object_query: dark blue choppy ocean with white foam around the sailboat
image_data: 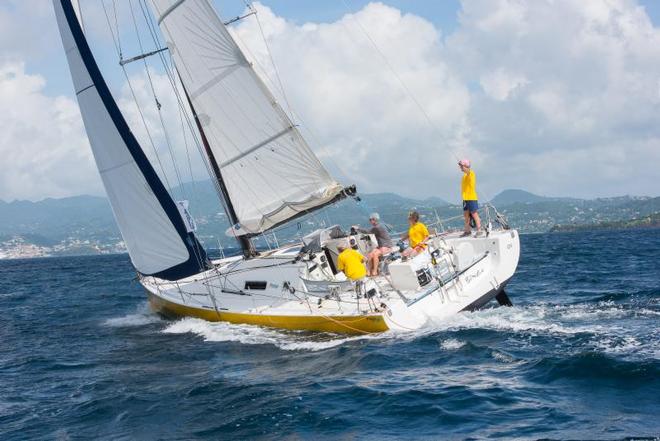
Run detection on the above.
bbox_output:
[0,229,660,440]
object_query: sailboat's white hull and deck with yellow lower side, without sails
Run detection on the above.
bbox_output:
[141,230,520,333]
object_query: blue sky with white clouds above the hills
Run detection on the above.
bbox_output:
[0,0,660,201]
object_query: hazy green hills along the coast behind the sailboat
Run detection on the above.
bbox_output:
[0,180,660,255]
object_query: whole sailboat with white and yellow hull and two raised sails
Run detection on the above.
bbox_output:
[53,0,520,334]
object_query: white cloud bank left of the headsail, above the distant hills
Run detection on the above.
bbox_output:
[0,62,100,200]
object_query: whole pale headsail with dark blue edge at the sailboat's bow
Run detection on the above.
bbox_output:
[53,0,208,280]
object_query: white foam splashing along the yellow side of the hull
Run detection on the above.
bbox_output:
[163,318,382,351]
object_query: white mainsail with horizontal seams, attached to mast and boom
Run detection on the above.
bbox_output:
[152,0,343,235]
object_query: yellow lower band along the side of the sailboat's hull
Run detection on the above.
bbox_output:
[148,293,389,334]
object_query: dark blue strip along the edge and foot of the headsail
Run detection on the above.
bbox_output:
[60,0,211,280]
